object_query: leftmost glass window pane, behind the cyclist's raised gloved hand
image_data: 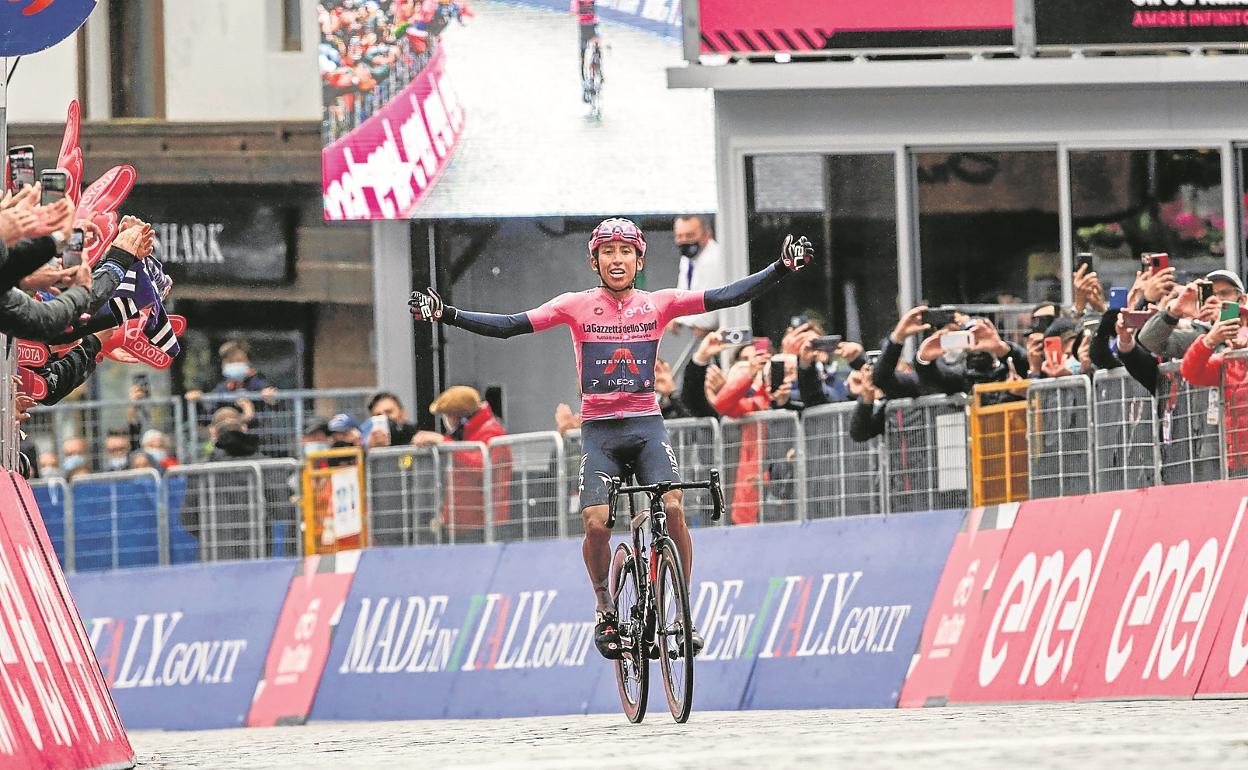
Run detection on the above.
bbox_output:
[745,154,897,348]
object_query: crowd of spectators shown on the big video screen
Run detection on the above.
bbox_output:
[318,0,472,141]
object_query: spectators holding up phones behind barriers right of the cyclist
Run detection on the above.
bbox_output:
[546,255,1248,524]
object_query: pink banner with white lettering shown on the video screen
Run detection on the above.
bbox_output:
[321,49,464,220]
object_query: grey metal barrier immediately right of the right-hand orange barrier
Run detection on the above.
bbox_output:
[1027,374,1096,499]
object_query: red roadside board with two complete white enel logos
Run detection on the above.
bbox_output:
[950,482,1248,703]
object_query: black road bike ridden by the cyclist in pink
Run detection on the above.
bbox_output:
[607,469,724,724]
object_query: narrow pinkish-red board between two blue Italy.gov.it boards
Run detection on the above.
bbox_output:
[247,550,361,728]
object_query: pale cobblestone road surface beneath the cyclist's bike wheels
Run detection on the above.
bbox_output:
[131,701,1248,770]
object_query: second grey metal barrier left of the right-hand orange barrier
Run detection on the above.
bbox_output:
[801,403,887,519]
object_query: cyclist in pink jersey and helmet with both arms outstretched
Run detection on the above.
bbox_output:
[408,218,815,658]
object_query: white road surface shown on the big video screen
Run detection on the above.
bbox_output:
[416,0,715,218]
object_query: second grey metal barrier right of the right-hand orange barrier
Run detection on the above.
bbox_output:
[1092,368,1161,492]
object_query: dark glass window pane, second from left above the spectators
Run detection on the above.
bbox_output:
[914,150,1062,306]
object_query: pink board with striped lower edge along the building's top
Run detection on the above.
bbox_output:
[699,0,1013,54]
